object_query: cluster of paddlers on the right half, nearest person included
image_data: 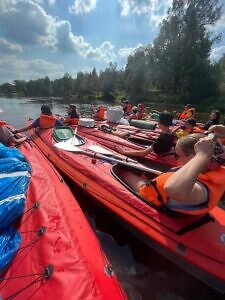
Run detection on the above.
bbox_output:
[89,101,225,214]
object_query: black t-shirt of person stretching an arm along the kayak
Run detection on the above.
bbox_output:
[152,133,173,154]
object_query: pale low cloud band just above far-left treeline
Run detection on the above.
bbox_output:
[0,56,65,83]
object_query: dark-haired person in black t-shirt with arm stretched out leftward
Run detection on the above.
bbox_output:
[117,112,174,157]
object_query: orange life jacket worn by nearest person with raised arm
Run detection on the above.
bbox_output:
[139,166,225,215]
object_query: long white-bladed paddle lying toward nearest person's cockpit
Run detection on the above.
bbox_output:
[54,142,162,175]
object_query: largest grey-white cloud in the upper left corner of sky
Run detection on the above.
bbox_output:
[0,0,115,61]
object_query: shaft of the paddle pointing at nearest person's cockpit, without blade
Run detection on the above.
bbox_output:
[79,149,162,175]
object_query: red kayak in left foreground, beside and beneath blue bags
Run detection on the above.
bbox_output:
[0,142,126,300]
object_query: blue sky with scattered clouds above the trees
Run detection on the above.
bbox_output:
[0,0,225,84]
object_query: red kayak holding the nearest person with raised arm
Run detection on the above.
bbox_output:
[27,127,225,292]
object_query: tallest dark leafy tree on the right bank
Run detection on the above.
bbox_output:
[151,0,222,101]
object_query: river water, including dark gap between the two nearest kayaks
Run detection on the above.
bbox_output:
[0,98,225,300]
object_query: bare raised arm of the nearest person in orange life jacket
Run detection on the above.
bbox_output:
[164,137,213,204]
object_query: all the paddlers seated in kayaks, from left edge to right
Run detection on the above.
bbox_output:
[0,103,225,214]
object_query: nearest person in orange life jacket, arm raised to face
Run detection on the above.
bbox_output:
[123,132,225,215]
